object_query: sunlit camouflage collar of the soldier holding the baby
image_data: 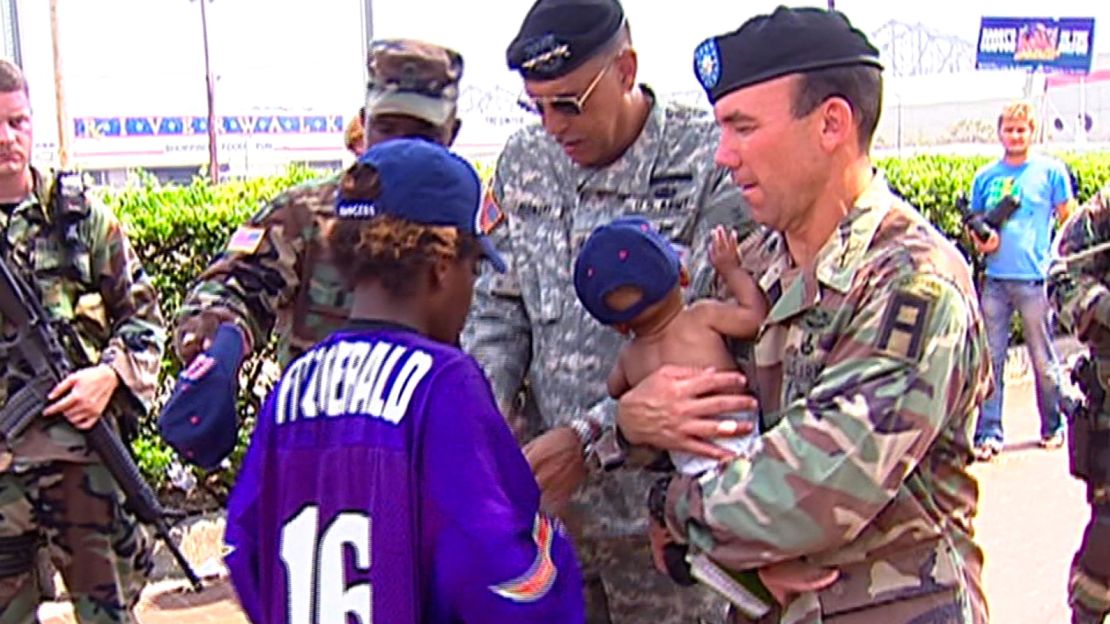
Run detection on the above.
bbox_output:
[815,171,892,293]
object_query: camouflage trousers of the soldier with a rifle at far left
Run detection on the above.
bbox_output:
[0,462,152,624]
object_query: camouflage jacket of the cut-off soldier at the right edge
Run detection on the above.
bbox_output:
[1049,187,1110,429]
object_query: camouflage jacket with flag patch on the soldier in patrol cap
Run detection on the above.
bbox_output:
[174,175,341,366]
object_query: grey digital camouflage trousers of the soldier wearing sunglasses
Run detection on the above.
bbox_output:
[576,535,728,624]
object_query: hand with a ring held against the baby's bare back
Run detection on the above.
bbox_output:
[617,364,757,460]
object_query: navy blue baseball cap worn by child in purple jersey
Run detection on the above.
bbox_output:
[335,139,506,273]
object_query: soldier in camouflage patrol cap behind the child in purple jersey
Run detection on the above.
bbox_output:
[173,40,463,366]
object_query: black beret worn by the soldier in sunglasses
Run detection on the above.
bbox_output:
[505,0,624,80]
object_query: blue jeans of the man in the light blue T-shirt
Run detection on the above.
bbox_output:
[975,278,1063,444]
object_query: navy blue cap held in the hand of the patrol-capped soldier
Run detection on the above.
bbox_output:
[158,323,244,470]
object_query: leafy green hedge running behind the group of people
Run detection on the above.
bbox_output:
[104,153,1110,504]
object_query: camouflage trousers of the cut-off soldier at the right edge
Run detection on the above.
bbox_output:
[1068,506,1110,624]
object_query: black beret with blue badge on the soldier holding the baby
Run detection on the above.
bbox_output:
[694,7,882,103]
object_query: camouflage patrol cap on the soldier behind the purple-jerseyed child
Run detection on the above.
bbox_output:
[366,39,463,125]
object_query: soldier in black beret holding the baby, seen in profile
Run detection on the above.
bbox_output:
[618,7,990,624]
